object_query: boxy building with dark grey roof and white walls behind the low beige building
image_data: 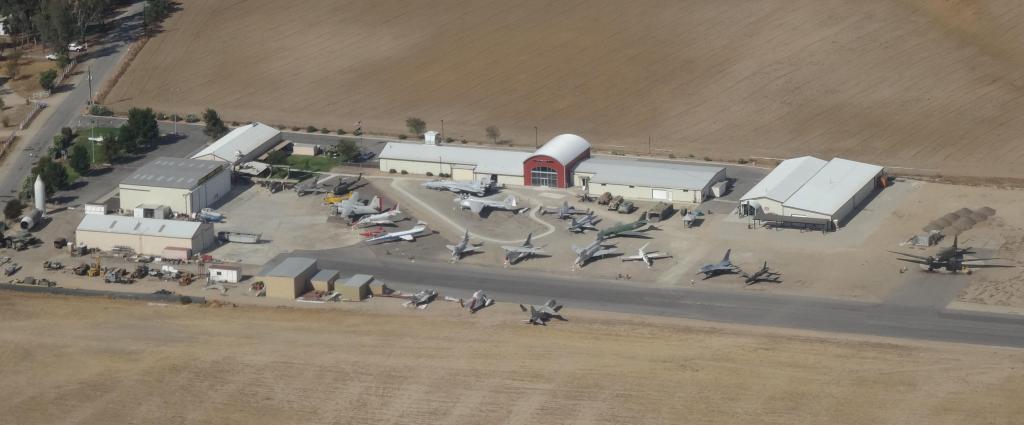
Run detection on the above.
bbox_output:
[118,157,231,214]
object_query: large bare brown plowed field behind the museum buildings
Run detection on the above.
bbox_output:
[105,0,1024,176]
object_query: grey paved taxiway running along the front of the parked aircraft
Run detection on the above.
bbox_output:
[296,248,1024,347]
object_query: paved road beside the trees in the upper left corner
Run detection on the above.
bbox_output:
[0,2,143,201]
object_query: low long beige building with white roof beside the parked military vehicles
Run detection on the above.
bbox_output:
[75,214,216,255]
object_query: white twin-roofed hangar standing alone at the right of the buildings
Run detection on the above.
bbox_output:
[739,157,885,229]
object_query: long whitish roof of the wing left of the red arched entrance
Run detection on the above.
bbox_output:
[378,142,530,176]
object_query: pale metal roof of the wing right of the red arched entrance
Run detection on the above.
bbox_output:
[575,157,725,190]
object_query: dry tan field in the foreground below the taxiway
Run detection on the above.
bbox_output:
[0,292,1024,424]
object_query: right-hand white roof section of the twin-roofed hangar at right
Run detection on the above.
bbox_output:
[782,158,882,215]
